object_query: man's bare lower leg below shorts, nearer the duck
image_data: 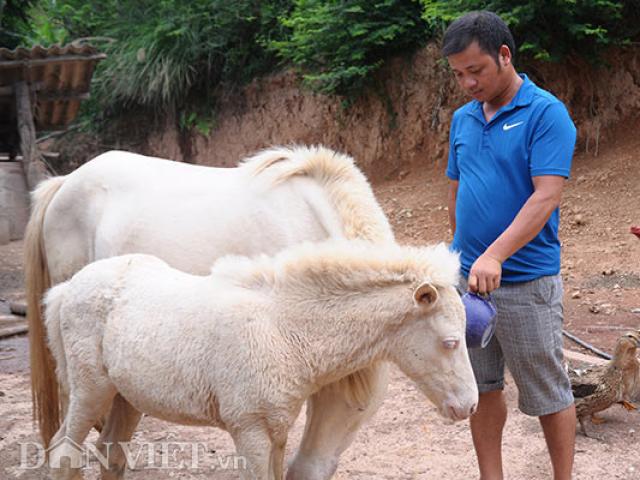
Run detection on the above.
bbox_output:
[540,405,576,480]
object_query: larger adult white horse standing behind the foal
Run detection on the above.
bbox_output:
[25,147,393,480]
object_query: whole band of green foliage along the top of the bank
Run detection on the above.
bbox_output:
[8,0,640,124]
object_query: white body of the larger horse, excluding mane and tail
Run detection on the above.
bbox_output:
[44,151,339,283]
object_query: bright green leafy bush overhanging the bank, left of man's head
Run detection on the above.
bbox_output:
[270,0,427,97]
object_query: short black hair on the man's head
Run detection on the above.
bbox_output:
[442,10,516,63]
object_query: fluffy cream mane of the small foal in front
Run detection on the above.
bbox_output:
[211,239,460,295]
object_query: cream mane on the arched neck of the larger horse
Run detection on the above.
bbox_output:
[241,145,394,243]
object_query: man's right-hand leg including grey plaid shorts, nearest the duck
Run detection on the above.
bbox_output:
[494,275,576,480]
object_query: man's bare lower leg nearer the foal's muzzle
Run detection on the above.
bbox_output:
[470,390,507,480]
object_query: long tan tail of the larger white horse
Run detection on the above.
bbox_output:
[24,177,65,447]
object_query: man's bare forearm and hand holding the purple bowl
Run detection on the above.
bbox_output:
[470,175,565,293]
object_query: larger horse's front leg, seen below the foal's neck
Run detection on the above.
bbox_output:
[287,363,388,480]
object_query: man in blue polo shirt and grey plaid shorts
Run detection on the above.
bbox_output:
[442,12,576,480]
